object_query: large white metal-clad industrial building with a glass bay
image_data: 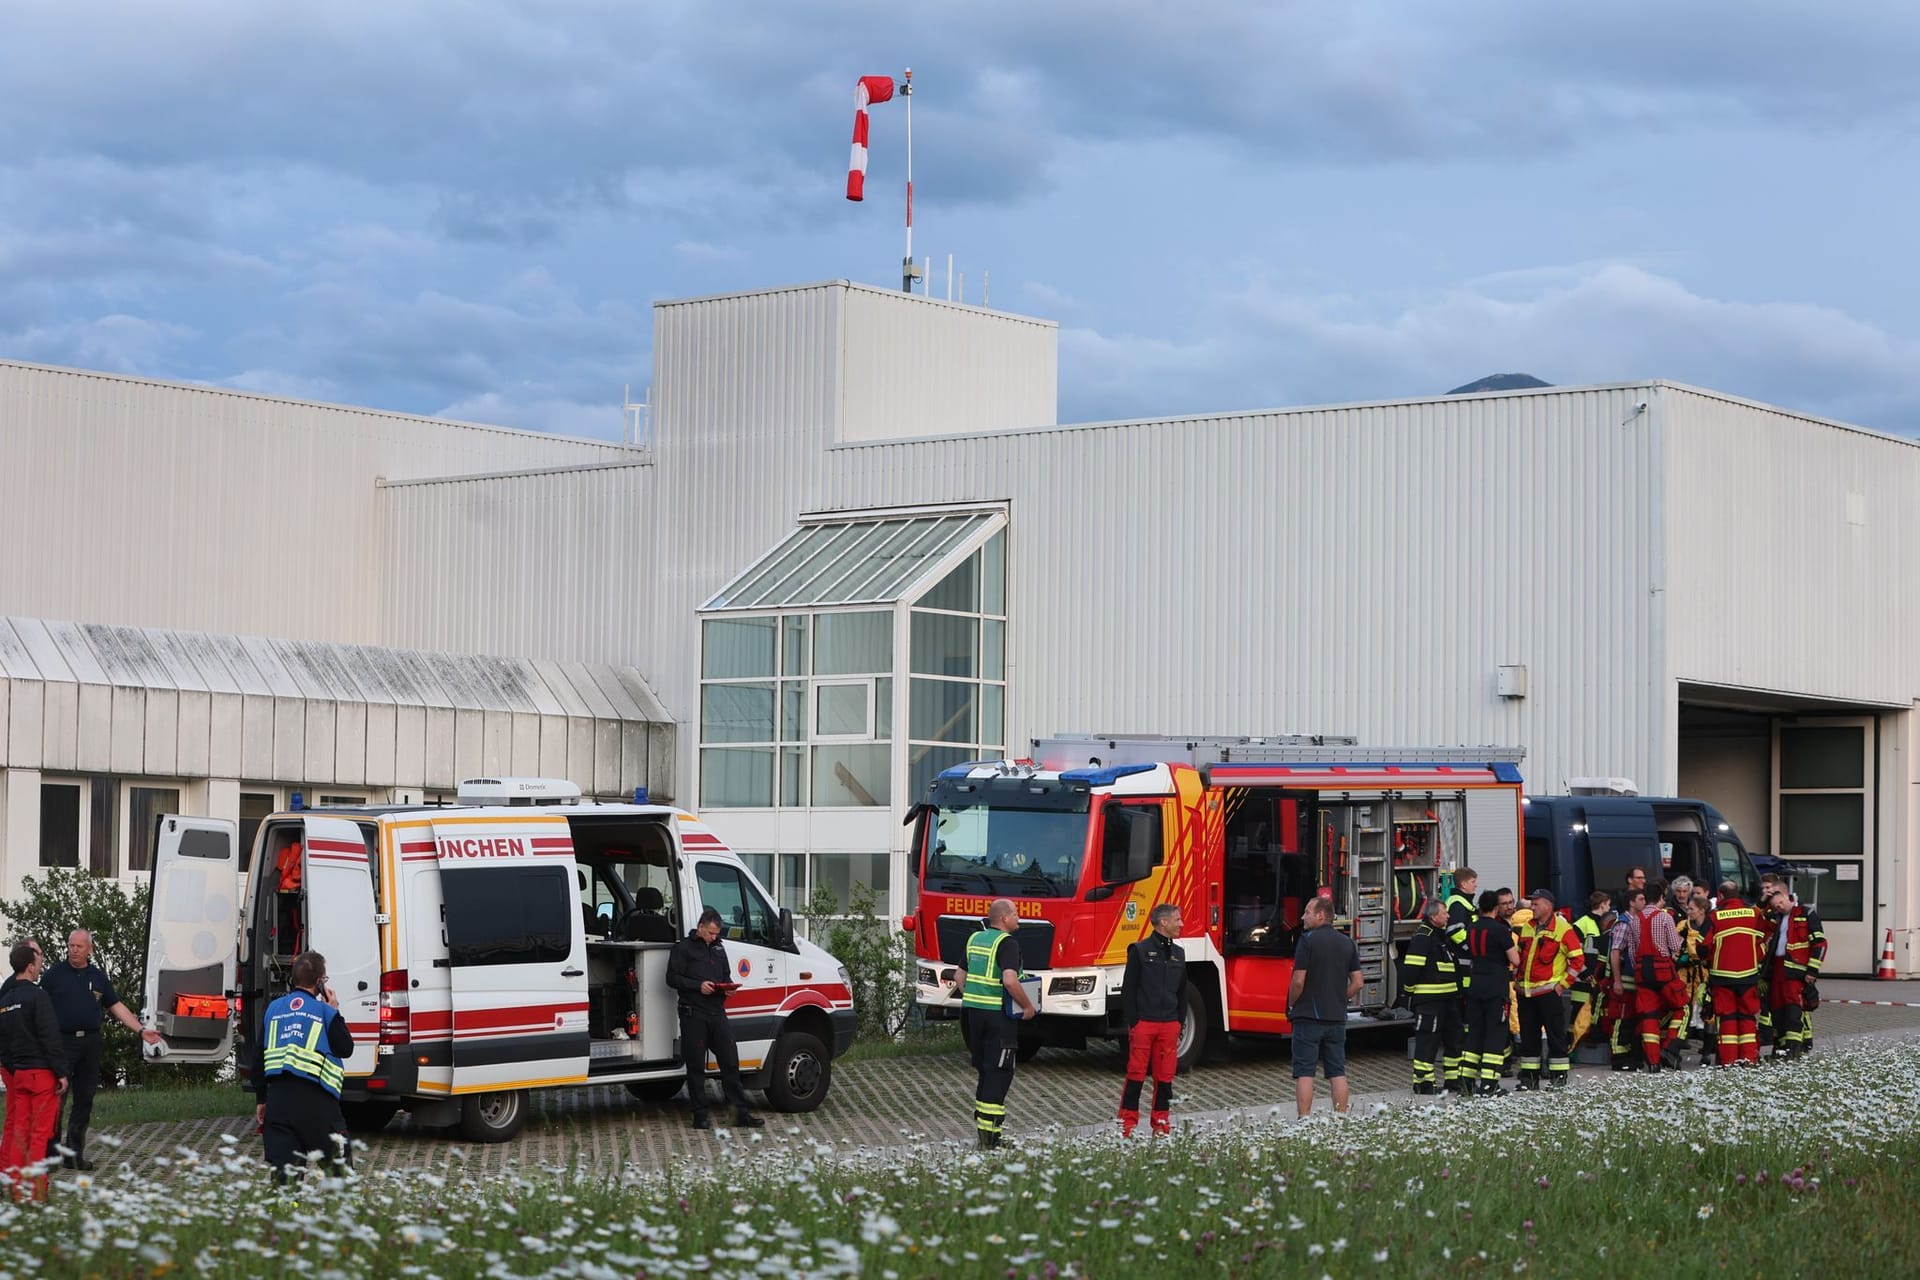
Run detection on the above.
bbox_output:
[0,282,1920,973]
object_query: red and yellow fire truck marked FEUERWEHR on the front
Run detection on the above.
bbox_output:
[904,735,1523,1069]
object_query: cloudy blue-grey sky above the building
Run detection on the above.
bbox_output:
[0,0,1920,436]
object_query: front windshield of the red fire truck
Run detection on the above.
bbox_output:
[924,779,1092,898]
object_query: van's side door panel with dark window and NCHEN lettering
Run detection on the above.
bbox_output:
[434,814,588,1094]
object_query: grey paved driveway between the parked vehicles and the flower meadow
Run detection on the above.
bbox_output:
[90,979,1920,1171]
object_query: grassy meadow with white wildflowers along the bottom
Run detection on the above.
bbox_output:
[0,1042,1920,1280]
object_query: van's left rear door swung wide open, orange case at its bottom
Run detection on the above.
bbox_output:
[142,814,240,1063]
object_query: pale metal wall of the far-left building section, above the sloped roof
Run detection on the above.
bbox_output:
[0,361,632,643]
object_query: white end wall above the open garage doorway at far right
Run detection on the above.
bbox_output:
[1659,386,1920,706]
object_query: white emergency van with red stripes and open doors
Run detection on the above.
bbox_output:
[144,779,854,1142]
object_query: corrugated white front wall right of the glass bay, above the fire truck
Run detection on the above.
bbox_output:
[802,386,1668,802]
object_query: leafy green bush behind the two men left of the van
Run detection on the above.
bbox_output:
[0,867,219,1086]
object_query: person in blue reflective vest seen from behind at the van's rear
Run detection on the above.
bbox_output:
[253,952,353,1182]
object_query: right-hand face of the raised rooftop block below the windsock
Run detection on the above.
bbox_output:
[839,284,1060,441]
